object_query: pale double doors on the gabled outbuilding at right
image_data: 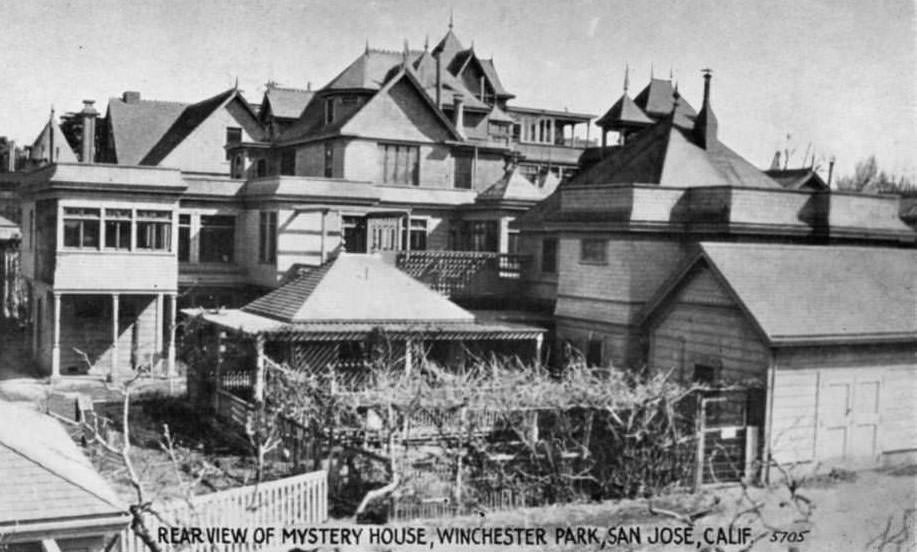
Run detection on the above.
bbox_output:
[818,371,882,468]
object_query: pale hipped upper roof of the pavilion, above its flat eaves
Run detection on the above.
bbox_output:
[242,253,474,323]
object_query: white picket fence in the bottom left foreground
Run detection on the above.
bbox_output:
[120,470,328,552]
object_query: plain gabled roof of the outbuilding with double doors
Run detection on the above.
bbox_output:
[645,242,917,346]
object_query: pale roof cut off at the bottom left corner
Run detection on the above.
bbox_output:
[0,401,127,534]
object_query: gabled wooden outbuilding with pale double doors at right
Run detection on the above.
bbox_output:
[643,242,917,476]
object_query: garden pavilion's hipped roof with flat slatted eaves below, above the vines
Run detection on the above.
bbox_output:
[184,253,546,401]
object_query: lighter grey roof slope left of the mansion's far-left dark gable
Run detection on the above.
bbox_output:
[107,98,188,165]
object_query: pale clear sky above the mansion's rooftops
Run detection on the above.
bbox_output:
[0,0,917,178]
